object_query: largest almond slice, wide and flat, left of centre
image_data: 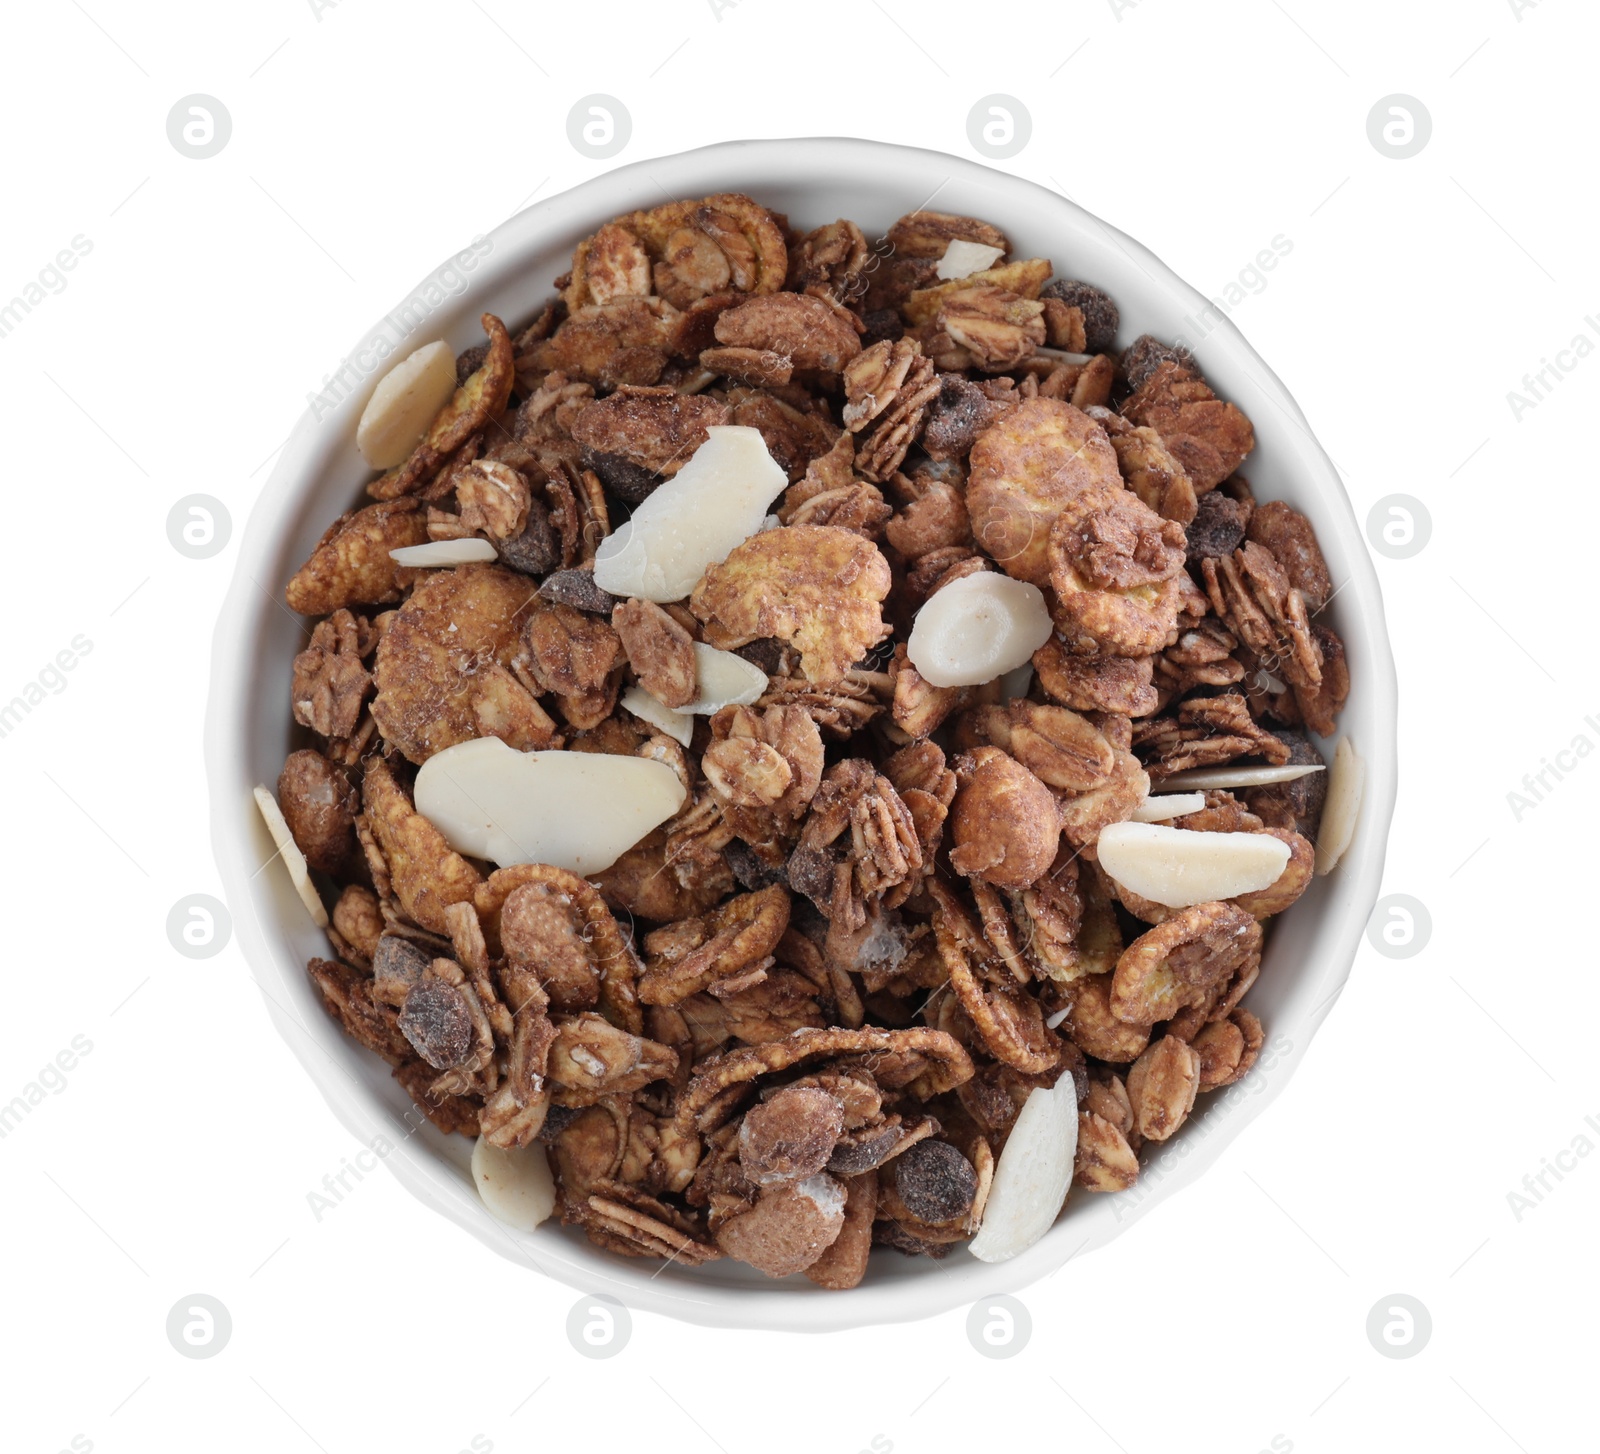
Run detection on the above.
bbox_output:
[416,737,685,873]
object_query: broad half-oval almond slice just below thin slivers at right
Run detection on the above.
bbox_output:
[1096,822,1290,909]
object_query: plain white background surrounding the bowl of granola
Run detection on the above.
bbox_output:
[0,0,1600,1454]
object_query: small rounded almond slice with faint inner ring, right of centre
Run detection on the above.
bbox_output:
[906,571,1053,686]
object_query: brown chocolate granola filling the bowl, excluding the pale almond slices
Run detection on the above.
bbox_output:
[278,194,1349,1289]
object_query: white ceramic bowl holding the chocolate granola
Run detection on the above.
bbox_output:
[206,138,1395,1329]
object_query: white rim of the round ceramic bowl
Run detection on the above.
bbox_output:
[205,136,1398,1331]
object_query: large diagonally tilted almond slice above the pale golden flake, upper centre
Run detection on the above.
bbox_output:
[595,424,789,601]
